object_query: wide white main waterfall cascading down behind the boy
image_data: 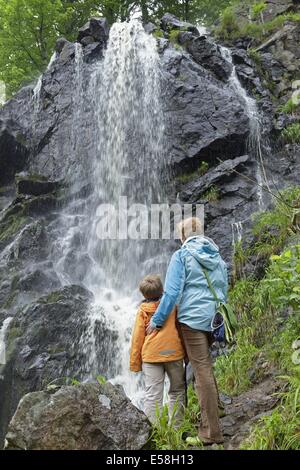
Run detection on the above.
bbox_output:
[53,20,167,403]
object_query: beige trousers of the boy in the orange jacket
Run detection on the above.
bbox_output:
[143,359,185,425]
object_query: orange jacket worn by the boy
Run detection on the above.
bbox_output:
[130,302,184,372]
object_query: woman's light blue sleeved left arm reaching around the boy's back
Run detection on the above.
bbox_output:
[150,250,185,328]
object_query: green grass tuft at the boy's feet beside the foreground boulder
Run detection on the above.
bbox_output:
[150,386,200,450]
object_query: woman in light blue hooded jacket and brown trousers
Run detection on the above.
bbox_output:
[147,217,228,445]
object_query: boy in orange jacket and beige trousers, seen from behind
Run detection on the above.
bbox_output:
[130,275,185,423]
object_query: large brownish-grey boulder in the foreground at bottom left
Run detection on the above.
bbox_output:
[5,383,151,450]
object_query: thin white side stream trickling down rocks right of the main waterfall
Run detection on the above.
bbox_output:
[220,46,268,210]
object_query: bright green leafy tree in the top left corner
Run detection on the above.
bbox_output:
[0,0,63,95]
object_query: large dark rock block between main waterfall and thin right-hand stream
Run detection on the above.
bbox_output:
[162,48,249,169]
